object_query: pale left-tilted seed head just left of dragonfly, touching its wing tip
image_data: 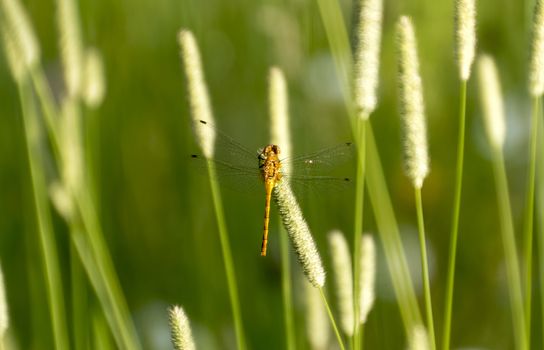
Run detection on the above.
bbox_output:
[178,29,215,158]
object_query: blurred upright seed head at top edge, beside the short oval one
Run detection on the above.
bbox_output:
[57,0,83,97]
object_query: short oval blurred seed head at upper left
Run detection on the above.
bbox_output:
[83,48,106,108]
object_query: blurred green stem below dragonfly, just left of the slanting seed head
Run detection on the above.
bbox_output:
[279,224,296,350]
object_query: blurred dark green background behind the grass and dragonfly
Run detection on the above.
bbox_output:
[0,0,542,349]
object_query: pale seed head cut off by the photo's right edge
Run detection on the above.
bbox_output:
[529,0,544,96]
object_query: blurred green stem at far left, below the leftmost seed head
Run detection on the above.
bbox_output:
[18,81,69,350]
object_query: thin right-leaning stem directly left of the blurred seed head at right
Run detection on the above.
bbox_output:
[442,80,467,350]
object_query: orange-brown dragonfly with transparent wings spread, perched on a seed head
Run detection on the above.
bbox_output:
[191,120,354,256]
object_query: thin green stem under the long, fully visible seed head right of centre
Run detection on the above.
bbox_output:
[415,188,436,350]
